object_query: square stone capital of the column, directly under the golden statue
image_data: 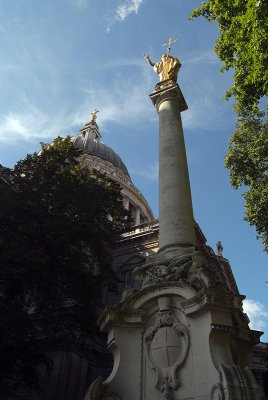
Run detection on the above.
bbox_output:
[150,80,188,112]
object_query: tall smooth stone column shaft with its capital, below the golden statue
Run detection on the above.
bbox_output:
[150,83,195,253]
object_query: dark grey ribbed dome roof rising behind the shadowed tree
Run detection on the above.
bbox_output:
[73,135,130,179]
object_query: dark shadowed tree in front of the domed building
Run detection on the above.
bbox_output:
[0,137,128,399]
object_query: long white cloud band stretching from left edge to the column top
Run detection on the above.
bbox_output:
[0,74,157,143]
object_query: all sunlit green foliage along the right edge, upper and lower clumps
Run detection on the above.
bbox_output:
[190,0,268,251]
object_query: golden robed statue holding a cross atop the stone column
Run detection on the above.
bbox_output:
[144,38,181,82]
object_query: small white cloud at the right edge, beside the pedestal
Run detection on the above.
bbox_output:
[243,299,268,331]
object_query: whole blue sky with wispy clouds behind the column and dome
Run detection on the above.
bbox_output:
[0,0,268,341]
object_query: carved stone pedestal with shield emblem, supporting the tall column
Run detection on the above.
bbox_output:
[86,253,259,400]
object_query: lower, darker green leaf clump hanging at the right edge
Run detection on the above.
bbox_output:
[226,119,268,251]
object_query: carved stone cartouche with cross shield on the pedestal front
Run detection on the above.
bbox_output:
[145,297,190,399]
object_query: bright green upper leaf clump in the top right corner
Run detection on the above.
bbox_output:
[191,0,268,115]
